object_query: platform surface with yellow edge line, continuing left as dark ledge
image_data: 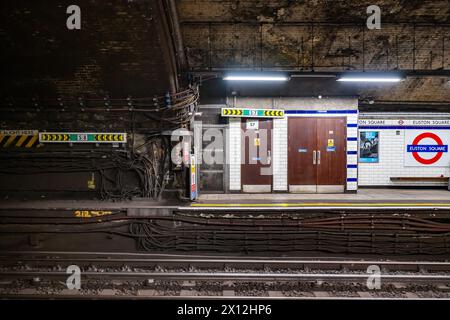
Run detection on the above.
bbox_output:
[0,188,450,212]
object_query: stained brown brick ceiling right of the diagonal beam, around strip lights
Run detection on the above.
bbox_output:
[177,0,450,105]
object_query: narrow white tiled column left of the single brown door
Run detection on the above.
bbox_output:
[227,118,241,191]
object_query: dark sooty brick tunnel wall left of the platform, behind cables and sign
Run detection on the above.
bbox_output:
[0,0,186,199]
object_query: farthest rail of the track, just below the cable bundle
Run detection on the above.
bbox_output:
[0,251,450,272]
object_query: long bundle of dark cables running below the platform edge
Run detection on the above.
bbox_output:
[129,215,450,254]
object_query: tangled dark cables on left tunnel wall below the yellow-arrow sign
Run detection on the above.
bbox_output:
[0,137,170,199]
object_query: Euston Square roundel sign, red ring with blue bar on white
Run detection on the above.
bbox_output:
[404,130,450,167]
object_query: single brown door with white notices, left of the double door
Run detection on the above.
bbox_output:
[241,119,272,192]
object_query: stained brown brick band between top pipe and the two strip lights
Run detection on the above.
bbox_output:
[182,21,450,72]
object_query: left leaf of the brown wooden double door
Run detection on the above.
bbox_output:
[288,118,317,192]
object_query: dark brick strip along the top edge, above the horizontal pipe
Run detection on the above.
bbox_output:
[177,0,450,23]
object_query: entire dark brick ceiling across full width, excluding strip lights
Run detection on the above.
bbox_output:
[0,0,450,105]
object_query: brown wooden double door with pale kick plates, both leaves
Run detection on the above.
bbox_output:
[288,117,347,193]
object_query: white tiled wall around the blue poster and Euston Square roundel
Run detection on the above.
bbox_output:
[358,129,450,186]
